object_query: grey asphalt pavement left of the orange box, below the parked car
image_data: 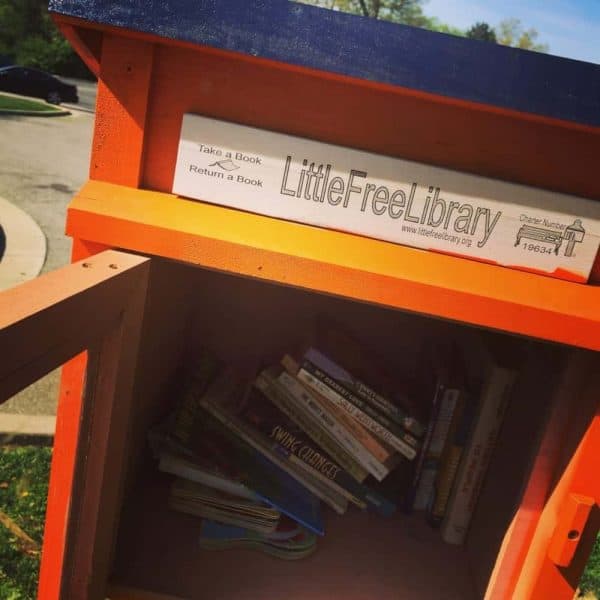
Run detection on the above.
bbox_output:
[0,81,95,415]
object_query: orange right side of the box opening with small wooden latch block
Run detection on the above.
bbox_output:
[486,351,600,600]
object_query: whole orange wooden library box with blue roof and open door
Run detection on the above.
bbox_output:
[0,0,600,600]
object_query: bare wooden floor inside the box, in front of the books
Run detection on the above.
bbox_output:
[112,474,475,600]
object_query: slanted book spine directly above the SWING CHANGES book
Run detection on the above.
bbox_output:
[256,373,367,482]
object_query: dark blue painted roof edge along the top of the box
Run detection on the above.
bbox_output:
[50,0,600,127]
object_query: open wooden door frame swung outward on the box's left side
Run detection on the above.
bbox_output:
[0,251,150,600]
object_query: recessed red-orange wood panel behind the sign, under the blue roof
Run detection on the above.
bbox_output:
[142,45,600,204]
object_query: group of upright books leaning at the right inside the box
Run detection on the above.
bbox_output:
[407,335,518,544]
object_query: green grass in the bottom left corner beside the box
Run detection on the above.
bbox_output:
[0,446,52,600]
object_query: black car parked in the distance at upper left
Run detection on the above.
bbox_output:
[0,66,79,104]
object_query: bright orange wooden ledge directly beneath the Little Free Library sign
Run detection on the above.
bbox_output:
[67,181,600,349]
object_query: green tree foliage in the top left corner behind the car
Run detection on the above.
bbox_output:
[0,0,91,78]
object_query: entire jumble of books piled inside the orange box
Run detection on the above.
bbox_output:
[150,328,516,559]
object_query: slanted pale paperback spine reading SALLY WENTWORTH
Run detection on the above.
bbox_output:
[298,361,417,460]
